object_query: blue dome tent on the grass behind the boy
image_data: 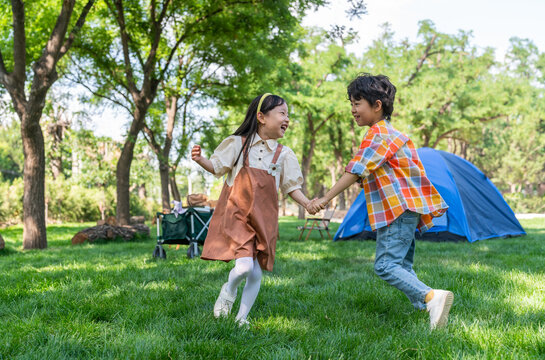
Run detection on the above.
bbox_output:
[334,148,526,242]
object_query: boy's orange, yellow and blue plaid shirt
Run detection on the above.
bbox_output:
[345,120,448,233]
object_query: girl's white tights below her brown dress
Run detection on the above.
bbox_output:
[223,257,262,320]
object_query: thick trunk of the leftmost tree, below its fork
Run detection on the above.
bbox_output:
[21,112,47,250]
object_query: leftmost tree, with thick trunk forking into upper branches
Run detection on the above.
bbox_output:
[0,0,94,249]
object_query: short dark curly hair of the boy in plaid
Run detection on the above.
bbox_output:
[346,73,397,120]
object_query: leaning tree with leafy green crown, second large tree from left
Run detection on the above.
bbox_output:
[73,0,323,224]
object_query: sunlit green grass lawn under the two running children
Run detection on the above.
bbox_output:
[0,218,545,359]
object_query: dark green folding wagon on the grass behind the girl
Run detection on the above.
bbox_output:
[153,207,214,259]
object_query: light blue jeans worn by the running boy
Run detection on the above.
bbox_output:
[375,211,431,310]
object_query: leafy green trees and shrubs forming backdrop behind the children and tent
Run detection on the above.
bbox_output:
[0,0,545,248]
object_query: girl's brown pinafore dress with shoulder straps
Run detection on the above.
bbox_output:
[201,144,282,271]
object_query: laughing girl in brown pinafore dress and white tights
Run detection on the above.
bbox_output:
[191,94,309,325]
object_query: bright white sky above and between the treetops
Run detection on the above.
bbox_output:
[93,0,545,140]
